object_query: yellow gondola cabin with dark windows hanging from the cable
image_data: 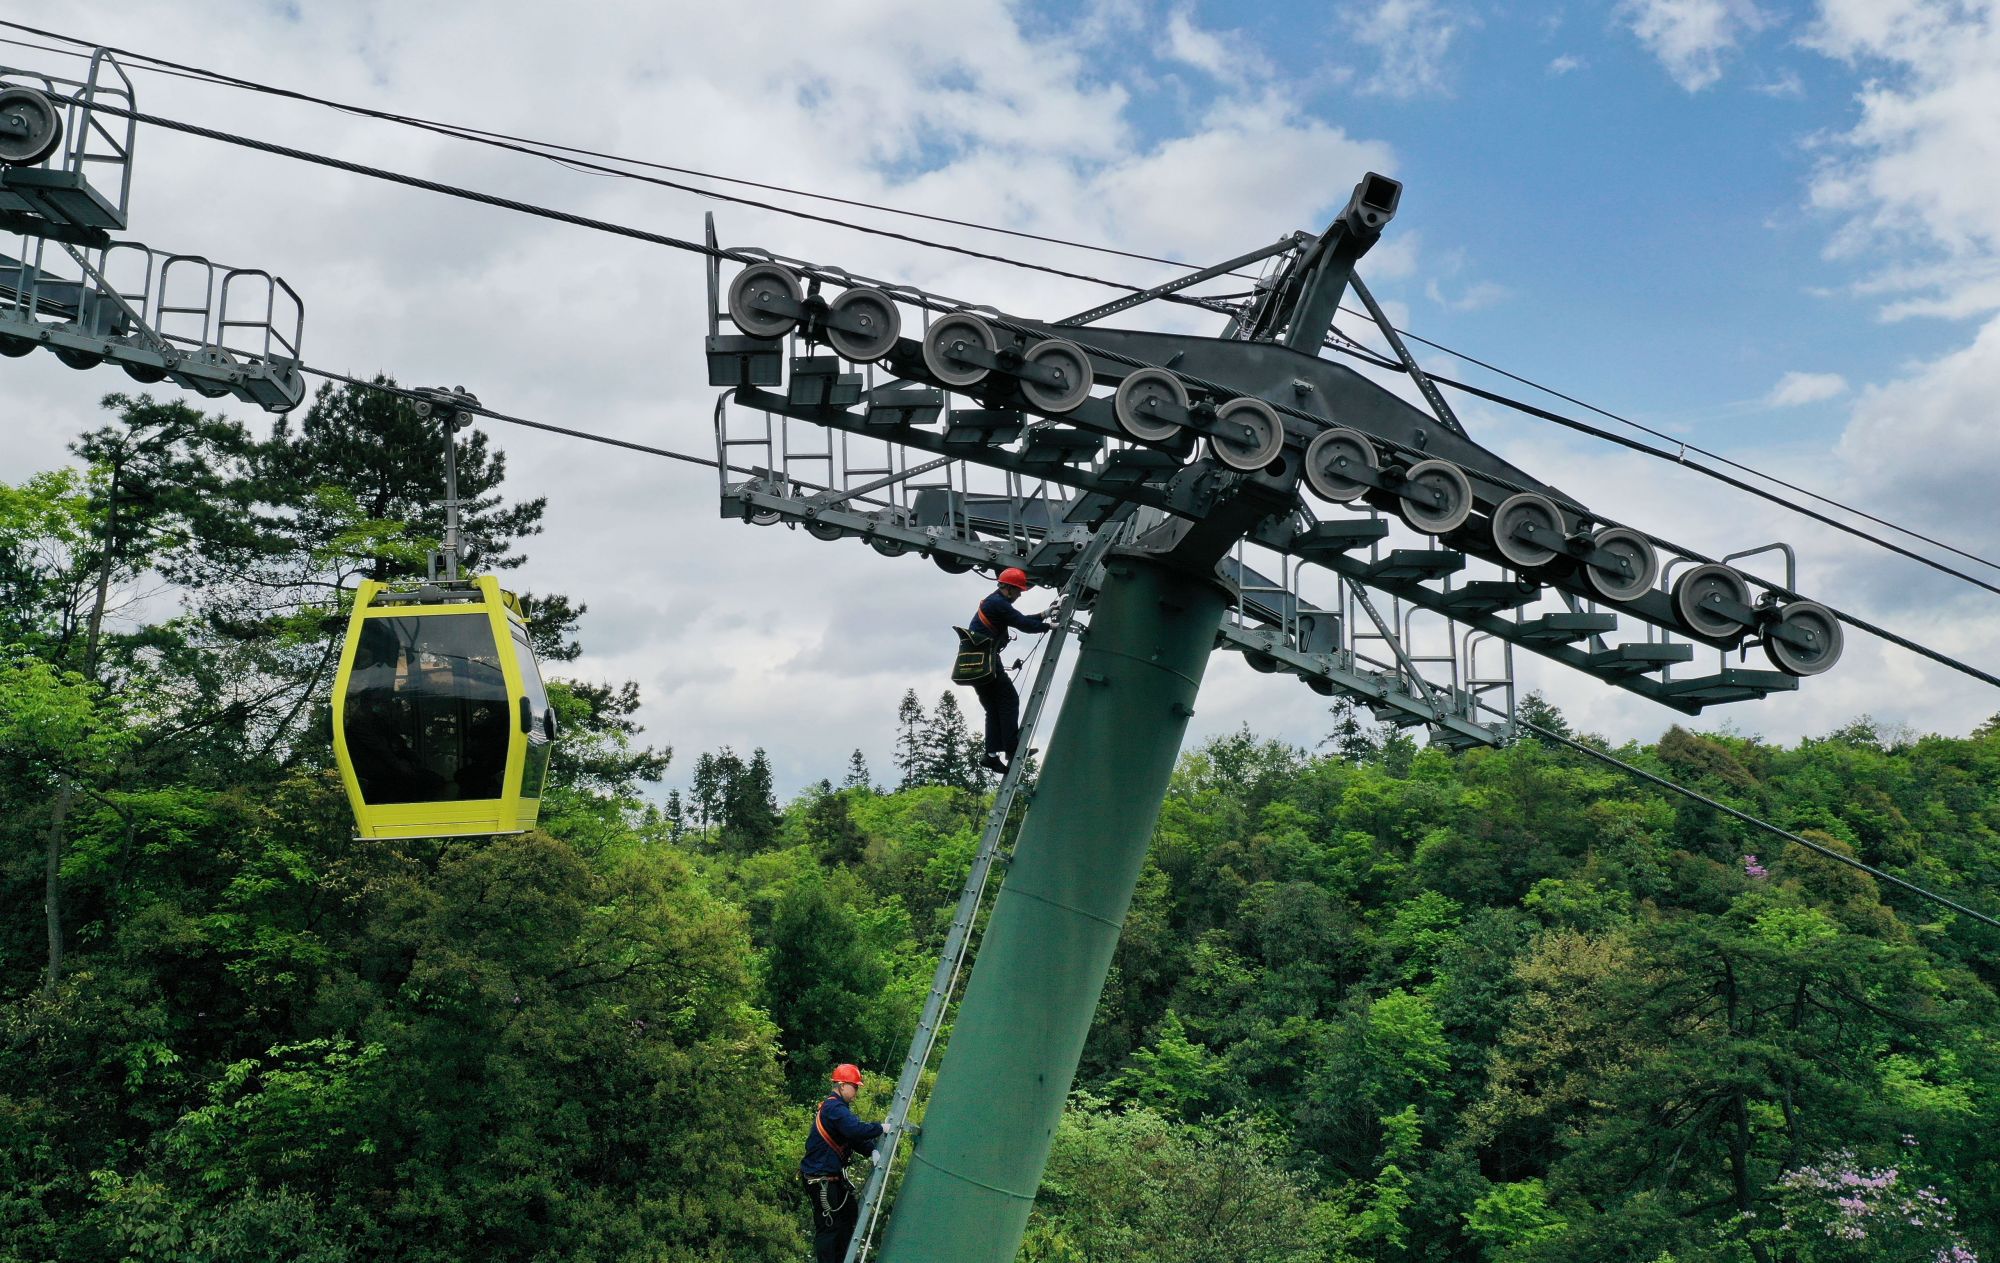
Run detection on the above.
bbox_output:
[334,576,556,837]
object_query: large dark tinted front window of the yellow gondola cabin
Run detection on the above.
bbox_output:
[342,614,514,803]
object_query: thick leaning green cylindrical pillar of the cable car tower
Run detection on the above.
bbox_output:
[880,554,1228,1263]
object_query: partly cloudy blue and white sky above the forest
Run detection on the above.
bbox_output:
[0,0,2000,793]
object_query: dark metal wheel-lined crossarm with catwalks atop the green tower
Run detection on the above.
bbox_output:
[706,190,1838,743]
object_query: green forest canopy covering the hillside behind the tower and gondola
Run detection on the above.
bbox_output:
[0,390,2000,1263]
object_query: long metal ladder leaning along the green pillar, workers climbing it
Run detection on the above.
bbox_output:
[846,518,1126,1263]
